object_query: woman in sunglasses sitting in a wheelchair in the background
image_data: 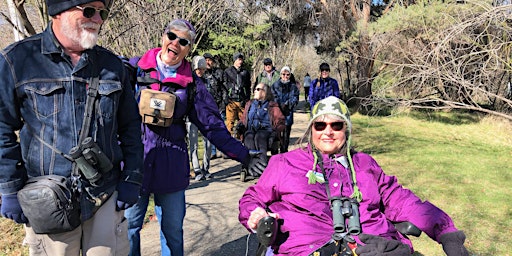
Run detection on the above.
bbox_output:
[236,83,286,177]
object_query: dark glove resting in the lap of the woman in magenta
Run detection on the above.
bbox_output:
[356,234,411,256]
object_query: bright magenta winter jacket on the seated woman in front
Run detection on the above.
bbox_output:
[239,149,457,255]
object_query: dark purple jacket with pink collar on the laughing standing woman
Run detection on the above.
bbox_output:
[138,48,248,193]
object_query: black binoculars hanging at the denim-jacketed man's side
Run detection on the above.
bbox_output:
[69,137,114,186]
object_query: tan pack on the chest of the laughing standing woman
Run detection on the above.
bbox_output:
[139,89,176,127]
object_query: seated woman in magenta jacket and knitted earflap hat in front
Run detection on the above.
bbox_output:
[239,96,468,256]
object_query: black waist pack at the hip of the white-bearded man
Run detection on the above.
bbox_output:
[18,175,81,234]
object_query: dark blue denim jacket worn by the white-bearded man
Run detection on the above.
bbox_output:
[0,23,143,219]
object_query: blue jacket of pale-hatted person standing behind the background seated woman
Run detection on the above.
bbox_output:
[272,79,300,126]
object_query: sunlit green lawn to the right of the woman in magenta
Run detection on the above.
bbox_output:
[0,109,512,256]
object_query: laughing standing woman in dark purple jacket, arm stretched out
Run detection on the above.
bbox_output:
[125,20,249,256]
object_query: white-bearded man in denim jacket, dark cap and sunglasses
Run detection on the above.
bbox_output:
[0,0,143,256]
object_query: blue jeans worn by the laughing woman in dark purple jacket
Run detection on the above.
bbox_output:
[125,190,185,256]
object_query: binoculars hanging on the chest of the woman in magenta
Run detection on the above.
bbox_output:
[331,197,361,239]
